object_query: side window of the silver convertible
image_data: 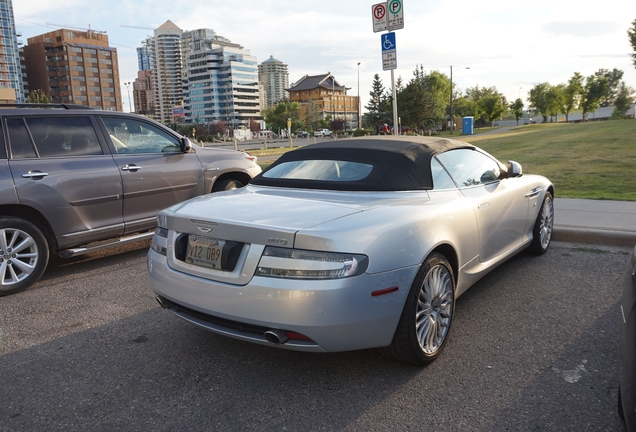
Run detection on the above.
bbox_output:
[437,149,500,187]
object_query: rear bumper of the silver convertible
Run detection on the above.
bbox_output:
[148,250,418,352]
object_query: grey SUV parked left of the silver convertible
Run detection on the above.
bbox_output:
[0,105,261,295]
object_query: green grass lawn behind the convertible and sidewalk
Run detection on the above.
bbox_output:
[250,120,636,201]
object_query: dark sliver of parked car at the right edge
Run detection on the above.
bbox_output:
[618,246,636,431]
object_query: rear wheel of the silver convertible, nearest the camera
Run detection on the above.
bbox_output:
[382,252,455,366]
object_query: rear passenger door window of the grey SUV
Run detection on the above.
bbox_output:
[25,117,103,158]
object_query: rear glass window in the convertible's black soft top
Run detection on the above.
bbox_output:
[263,160,373,182]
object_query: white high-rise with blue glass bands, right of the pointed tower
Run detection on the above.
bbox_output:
[183,32,262,129]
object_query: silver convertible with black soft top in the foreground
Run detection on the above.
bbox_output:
[148,137,554,365]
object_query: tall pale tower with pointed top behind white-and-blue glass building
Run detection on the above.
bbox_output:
[144,20,183,124]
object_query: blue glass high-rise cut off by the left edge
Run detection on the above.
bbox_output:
[0,0,24,103]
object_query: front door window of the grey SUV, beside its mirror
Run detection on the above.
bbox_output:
[102,116,181,154]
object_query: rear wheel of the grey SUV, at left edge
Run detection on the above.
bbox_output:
[0,217,49,297]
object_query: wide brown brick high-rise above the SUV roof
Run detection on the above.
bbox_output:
[23,29,122,111]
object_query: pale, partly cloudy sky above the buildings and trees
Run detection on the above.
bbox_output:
[13,0,636,113]
